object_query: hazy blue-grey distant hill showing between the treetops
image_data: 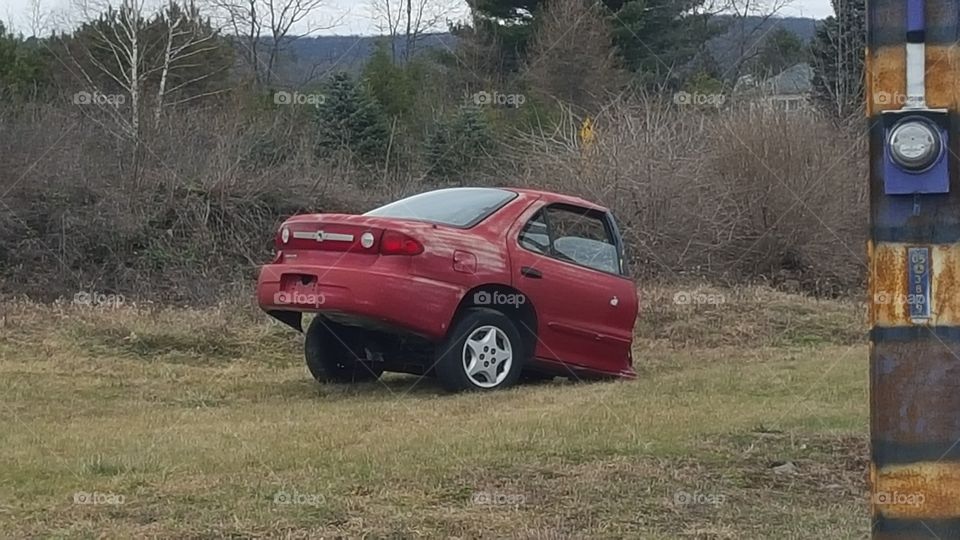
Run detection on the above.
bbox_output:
[276,16,819,84]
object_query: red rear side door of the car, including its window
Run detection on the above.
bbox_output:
[508,203,637,373]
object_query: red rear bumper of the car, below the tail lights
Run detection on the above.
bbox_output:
[257,264,466,340]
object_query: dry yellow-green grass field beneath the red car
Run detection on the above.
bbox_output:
[0,290,869,539]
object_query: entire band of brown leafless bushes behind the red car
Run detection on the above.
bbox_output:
[0,87,867,302]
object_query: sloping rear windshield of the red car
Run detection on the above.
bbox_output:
[364,188,517,228]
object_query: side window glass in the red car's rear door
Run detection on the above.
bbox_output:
[518,206,622,275]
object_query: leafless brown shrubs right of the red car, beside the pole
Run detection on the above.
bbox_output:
[502,96,867,294]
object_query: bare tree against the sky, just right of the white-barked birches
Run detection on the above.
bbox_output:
[211,0,342,85]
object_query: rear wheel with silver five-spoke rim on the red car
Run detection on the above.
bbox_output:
[436,308,527,392]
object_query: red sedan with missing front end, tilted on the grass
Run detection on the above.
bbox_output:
[257,188,638,391]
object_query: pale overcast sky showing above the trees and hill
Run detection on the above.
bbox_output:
[0,0,833,35]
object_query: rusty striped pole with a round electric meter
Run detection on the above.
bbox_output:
[866,0,960,539]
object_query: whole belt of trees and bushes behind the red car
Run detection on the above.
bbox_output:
[0,0,864,299]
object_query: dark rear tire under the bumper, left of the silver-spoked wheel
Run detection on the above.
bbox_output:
[304,315,383,383]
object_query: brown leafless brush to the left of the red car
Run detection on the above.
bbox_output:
[0,100,379,302]
